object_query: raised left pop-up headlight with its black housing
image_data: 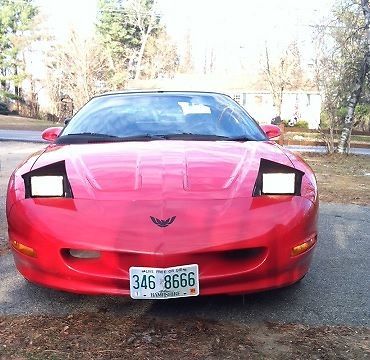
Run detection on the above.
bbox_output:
[23,161,73,198]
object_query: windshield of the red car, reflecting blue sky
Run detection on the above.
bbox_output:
[57,93,266,143]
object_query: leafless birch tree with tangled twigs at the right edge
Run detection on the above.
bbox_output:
[315,0,369,153]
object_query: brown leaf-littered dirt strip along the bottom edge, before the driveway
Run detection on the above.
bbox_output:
[0,311,370,360]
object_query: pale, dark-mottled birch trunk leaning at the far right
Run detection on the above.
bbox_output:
[338,0,370,154]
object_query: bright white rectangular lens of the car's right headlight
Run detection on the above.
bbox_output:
[262,173,295,194]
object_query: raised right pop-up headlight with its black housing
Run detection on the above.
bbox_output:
[253,159,304,196]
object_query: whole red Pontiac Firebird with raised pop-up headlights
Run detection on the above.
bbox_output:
[6,91,318,299]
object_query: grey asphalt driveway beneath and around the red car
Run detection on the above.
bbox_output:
[0,143,370,326]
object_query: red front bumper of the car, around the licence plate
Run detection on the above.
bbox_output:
[8,196,317,296]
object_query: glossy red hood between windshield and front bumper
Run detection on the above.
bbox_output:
[32,140,292,200]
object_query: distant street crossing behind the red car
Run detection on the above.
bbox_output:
[0,130,370,155]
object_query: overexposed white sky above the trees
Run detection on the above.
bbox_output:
[36,0,334,72]
